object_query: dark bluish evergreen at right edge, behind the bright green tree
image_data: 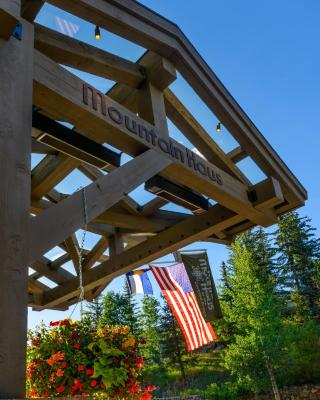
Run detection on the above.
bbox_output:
[275,212,320,316]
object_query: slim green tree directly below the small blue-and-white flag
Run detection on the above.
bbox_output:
[139,296,161,365]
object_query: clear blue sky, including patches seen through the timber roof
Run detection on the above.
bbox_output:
[29,0,320,327]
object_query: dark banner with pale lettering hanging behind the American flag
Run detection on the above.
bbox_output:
[180,252,222,321]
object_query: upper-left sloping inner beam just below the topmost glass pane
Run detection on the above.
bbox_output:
[35,24,146,87]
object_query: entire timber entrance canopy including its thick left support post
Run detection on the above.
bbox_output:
[0,0,307,398]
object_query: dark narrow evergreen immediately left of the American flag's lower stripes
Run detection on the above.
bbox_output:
[160,301,186,381]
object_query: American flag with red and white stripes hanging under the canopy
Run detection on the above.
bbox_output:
[150,263,216,351]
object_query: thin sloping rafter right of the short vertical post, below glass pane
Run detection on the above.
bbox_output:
[164,89,250,185]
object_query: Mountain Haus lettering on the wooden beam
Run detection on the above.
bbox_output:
[83,83,223,186]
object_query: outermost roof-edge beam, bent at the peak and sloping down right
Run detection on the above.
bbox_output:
[44,0,307,203]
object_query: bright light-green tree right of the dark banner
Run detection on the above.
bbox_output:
[224,230,282,399]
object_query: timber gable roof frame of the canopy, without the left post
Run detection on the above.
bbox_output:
[5,0,307,310]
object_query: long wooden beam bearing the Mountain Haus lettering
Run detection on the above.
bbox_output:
[34,51,275,225]
